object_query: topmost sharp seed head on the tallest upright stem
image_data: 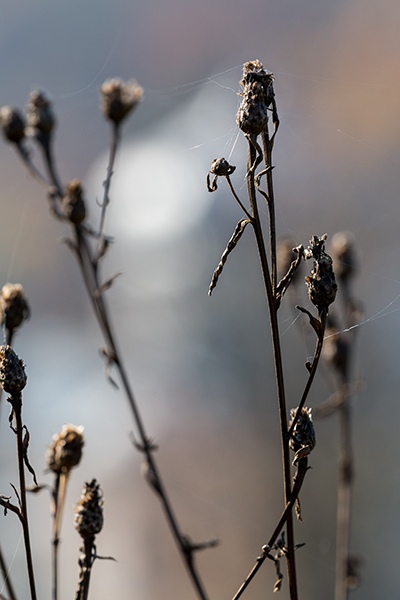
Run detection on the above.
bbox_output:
[236,60,275,135]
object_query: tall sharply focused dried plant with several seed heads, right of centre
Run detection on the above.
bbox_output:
[207,60,337,600]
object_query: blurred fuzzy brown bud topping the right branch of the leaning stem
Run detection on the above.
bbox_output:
[100,79,143,125]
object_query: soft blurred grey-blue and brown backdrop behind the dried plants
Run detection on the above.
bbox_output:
[0,0,400,600]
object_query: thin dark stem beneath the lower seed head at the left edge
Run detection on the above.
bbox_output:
[11,395,36,600]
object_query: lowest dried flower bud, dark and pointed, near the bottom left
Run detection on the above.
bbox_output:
[74,479,104,538]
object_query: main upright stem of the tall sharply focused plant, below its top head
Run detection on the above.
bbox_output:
[247,139,298,600]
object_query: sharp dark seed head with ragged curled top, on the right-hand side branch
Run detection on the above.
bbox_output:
[304,235,338,312]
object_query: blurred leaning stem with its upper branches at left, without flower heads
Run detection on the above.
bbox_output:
[25,130,211,600]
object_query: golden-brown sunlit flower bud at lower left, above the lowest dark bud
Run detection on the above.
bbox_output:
[46,425,85,473]
